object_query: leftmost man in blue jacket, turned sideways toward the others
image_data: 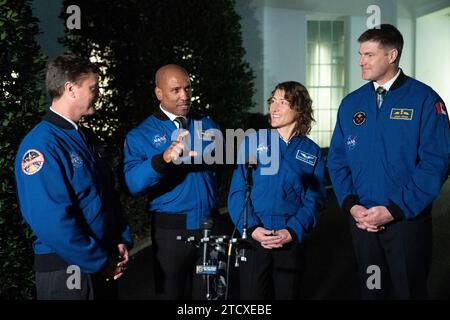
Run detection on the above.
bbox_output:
[15,55,131,300]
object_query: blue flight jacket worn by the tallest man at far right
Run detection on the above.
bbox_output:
[328,72,450,220]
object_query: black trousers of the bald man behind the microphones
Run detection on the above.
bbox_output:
[152,214,206,300]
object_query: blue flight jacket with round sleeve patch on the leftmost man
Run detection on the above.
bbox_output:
[14,111,132,273]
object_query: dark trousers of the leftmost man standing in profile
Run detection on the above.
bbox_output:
[36,269,118,300]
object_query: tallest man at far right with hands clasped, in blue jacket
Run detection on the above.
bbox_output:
[328,24,450,299]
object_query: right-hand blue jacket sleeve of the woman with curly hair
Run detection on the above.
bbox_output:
[287,150,326,242]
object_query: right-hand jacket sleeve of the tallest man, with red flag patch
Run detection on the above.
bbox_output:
[388,94,450,219]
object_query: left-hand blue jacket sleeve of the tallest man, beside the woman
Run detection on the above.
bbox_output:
[327,104,359,212]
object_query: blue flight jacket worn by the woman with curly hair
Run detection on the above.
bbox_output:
[228,129,325,242]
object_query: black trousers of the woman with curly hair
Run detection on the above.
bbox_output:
[239,239,305,300]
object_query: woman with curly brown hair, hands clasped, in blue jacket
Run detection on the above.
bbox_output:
[228,81,325,299]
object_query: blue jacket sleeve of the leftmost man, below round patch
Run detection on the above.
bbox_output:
[15,147,108,273]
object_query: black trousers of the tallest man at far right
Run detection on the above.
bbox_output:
[349,213,432,300]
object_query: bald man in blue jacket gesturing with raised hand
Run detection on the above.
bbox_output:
[124,64,221,299]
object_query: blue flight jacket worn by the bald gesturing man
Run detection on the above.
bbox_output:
[124,108,223,230]
